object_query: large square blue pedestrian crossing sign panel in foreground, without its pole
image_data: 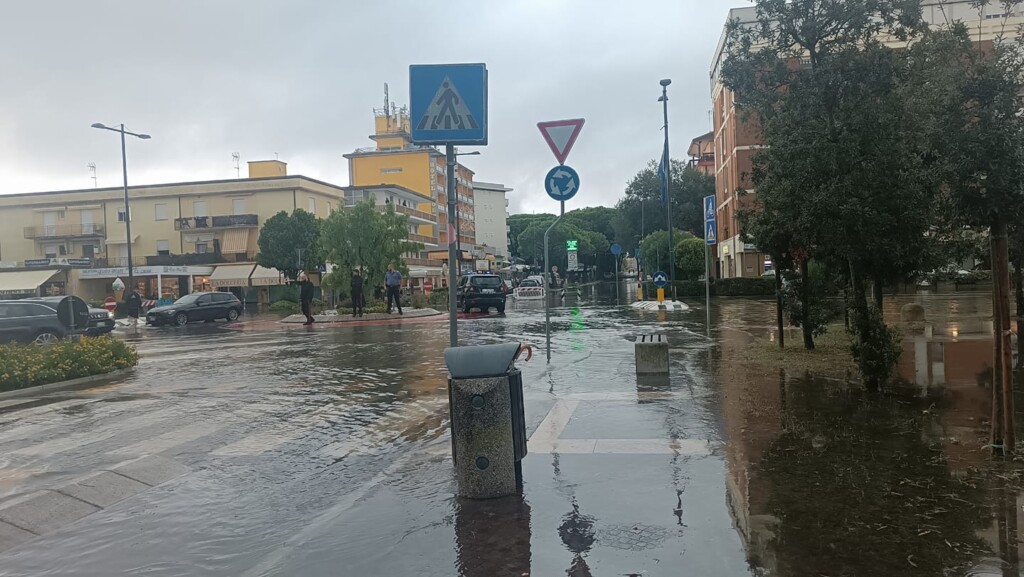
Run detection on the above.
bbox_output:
[409,64,487,145]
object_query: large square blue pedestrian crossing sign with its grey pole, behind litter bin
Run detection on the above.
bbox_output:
[409,64,487,346]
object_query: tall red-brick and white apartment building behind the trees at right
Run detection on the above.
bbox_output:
[708,0,1024,278]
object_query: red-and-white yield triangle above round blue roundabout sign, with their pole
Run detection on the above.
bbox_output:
[537,118,585,363]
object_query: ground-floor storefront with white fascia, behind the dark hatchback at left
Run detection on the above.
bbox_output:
[75,266,214,300]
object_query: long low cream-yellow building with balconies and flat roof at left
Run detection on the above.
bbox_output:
[0,161,345,301]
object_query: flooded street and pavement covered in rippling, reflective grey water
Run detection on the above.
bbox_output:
[0,292,1024,577]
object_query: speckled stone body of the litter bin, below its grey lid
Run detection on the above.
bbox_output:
[450,376,517,499]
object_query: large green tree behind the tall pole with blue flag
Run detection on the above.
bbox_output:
[614,160,715,252]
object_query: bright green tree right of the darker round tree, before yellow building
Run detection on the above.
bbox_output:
[322,199,423,287]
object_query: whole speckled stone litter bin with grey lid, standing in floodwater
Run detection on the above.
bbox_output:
[444,343,526,499]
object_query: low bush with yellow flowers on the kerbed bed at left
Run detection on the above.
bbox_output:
[0,336,138,390]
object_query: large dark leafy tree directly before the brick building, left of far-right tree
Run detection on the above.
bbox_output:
[723,0,937,379]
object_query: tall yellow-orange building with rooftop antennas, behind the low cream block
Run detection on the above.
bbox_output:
[345,108,476,278]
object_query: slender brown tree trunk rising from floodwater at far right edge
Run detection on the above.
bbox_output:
[991,216,1017,455]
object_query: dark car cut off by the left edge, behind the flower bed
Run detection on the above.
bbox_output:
[0,296,89,344]
